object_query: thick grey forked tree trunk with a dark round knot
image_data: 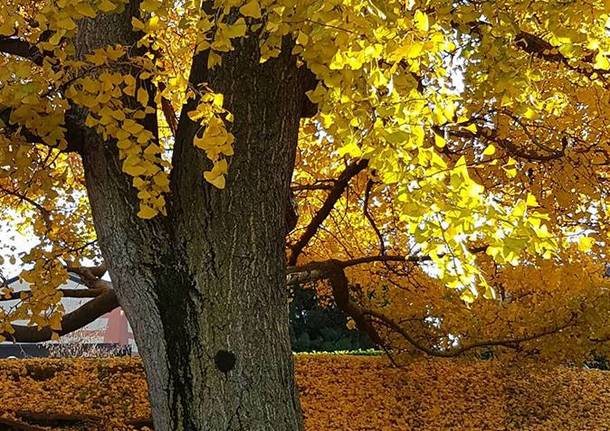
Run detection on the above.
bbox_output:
[74,2,306,431]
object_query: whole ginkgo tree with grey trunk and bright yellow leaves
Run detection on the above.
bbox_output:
[0,0,610,430]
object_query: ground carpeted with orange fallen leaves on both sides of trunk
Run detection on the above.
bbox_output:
[0,355,610,431]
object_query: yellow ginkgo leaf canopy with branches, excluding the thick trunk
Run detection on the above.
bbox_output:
[0,0,610,360]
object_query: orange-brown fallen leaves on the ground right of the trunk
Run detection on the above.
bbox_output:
[296,355,610,431]
